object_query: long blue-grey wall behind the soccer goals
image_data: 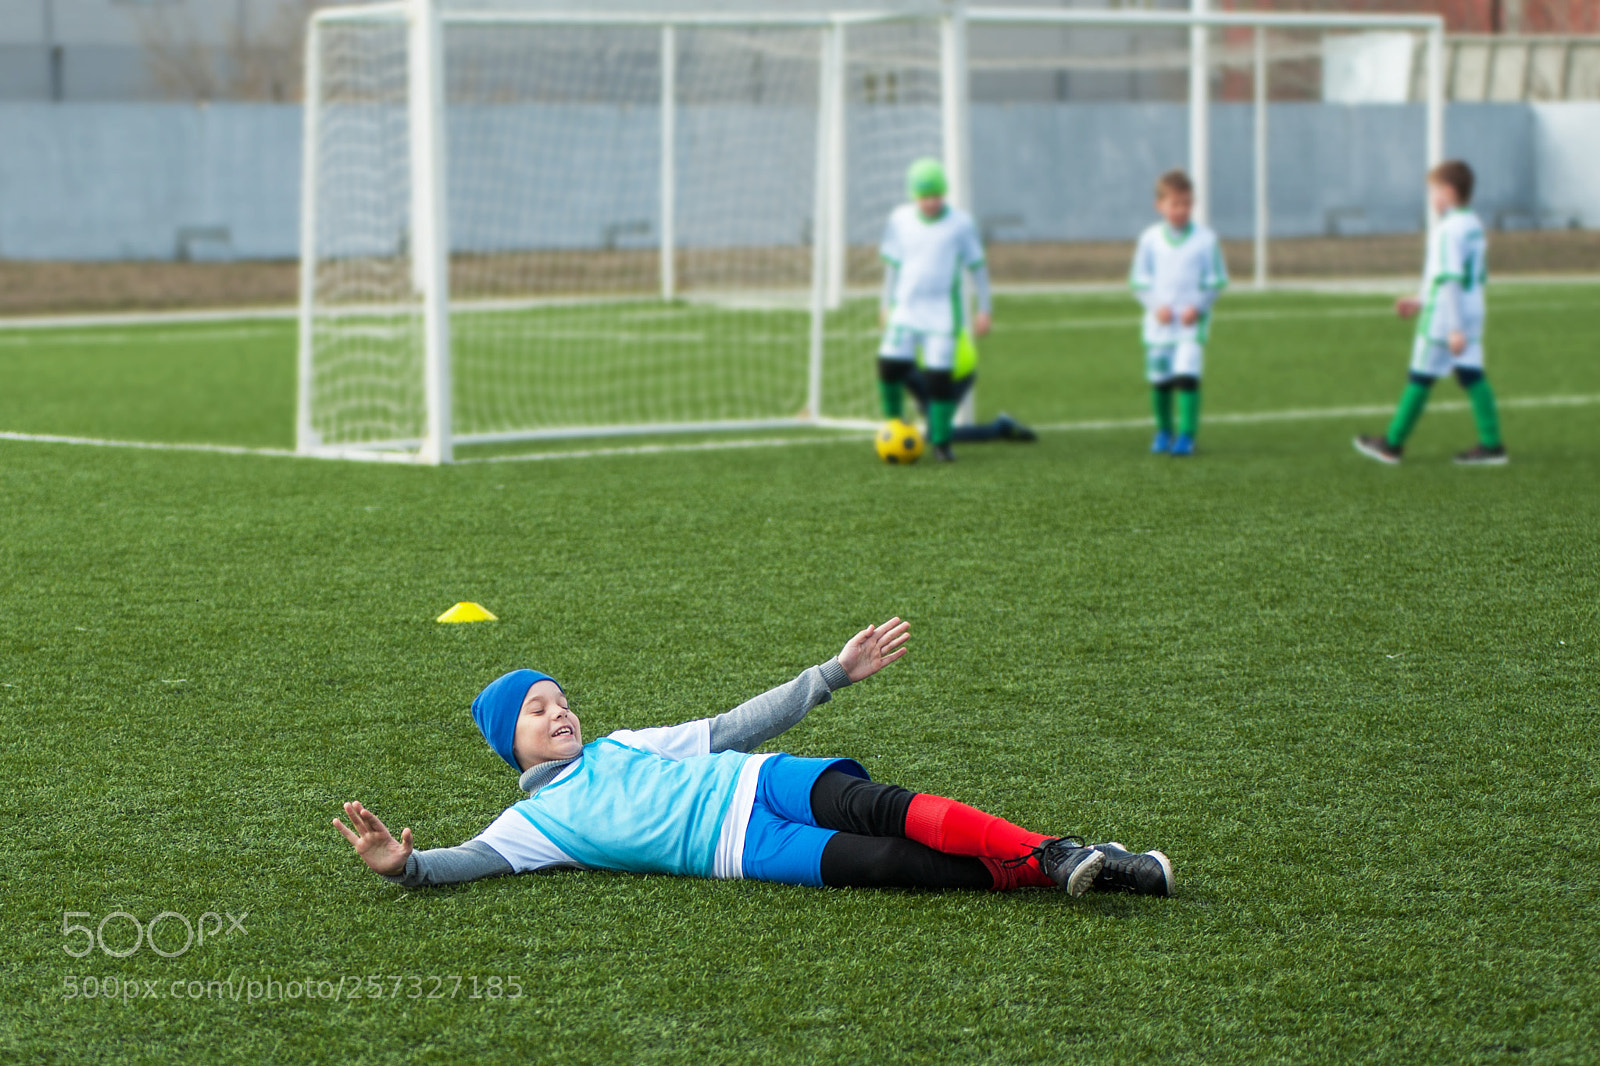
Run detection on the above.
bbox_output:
[0,104,1600,259]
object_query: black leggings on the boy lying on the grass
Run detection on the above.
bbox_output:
[811,770,994,888]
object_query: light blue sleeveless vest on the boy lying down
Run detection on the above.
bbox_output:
[514,738,750,877]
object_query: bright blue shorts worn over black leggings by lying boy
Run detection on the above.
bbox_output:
[744,755,867,888]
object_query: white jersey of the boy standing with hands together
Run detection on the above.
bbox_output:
[1128,222,1227,346]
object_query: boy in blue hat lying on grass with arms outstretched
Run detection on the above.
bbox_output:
[333,618,1173,896]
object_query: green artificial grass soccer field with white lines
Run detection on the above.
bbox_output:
[0,285,1600,1064]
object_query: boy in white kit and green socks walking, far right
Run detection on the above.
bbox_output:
[1355,160,1506,466]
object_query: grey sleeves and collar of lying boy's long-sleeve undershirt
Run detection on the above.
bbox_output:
[384,658,850,888]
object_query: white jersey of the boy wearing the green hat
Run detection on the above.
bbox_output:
[878,203,984,333]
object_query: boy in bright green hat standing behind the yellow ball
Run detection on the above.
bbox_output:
[878,158,990,463]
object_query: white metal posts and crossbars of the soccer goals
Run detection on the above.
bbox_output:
[296,0,1445,464]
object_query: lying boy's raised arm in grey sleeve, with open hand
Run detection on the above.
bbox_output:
[710,618,910,751]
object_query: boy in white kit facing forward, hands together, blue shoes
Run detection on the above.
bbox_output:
[1128,170,1227,456]
